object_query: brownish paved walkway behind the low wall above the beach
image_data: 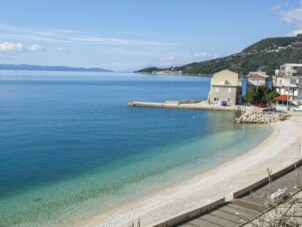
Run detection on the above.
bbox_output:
[178,166,302,227]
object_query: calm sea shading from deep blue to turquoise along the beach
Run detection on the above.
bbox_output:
[0,72,271,226]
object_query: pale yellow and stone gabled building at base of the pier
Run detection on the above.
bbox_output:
[208,70,240,105]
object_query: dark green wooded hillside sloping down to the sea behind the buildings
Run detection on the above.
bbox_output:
[136,35,302,75]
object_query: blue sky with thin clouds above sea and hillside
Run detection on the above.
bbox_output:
[0,0,302,71]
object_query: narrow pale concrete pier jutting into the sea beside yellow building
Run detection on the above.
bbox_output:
[128,100,245,111]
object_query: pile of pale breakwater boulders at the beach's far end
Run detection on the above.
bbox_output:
[234,108,287,124]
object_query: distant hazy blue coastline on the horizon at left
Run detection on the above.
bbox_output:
[0,64,113,72]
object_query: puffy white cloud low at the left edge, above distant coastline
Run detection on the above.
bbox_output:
[0,42,44,54]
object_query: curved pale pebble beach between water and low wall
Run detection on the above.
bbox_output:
[78,117,302,226]
